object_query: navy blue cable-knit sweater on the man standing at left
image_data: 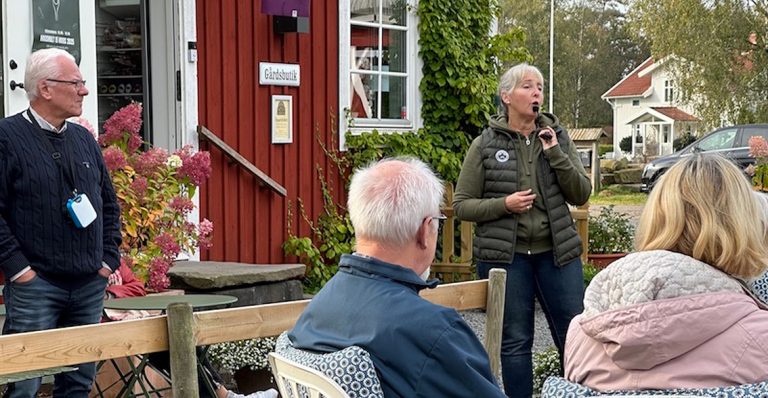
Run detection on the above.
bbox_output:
[0,113,121,287]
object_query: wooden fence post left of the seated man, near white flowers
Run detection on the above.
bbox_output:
[168,303,200,398]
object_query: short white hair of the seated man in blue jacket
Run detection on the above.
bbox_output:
[347,157,444,246]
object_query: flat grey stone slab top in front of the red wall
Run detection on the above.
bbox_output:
[168,261,306,290]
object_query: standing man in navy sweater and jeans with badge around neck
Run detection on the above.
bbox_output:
[0,49,120,397]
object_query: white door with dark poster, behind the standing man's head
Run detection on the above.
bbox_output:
[0,0,96,124]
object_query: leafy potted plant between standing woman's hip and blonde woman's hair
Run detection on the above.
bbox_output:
[587,205,635,268]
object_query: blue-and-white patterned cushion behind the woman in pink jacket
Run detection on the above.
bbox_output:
[541,376,768,398]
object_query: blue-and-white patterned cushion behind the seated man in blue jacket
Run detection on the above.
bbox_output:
[275,333,384,398]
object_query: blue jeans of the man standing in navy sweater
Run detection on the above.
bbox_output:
[3,275,107,398]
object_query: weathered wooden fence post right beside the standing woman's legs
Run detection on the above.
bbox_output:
[485,268,507,376]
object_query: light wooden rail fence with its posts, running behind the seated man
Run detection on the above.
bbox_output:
[0,273,505,392]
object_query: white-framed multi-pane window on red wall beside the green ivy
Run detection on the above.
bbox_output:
[339,0,419,135]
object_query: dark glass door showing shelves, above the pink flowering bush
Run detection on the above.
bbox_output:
[95,0,151,141]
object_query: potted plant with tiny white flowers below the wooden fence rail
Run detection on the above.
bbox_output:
[208,337,277,393]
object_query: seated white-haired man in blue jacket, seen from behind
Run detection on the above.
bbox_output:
[288,158,504,397]
